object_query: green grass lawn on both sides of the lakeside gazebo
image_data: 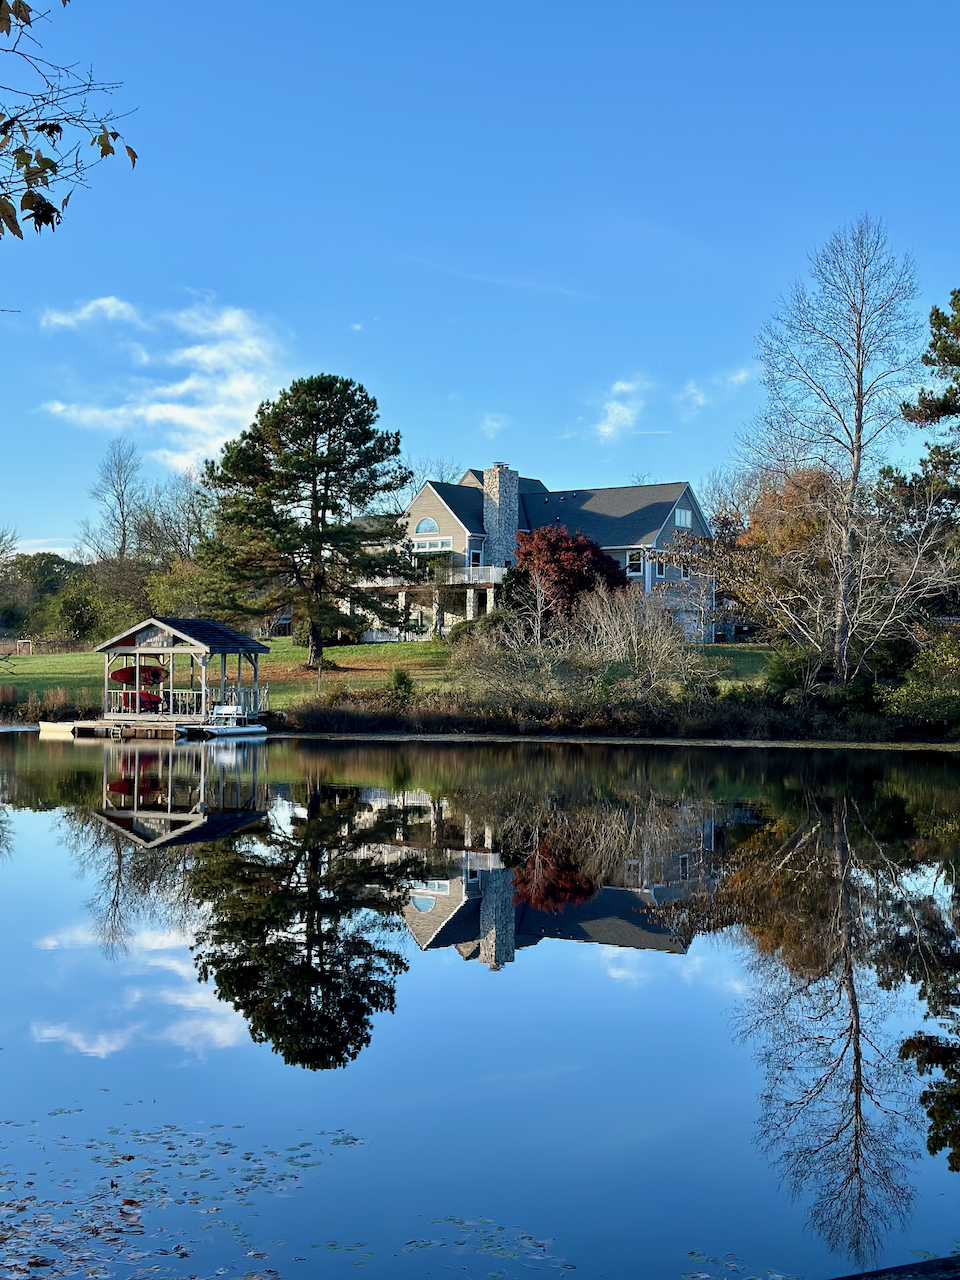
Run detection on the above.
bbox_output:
[0,639,447,710]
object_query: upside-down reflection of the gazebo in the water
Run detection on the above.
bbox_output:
[93,740,266,849]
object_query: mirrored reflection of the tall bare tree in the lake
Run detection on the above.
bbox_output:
[739,797,915,1262]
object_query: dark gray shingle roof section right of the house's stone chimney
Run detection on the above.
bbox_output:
[520,480,686,547]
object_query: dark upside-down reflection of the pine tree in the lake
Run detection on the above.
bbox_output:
[191,787,411,1070]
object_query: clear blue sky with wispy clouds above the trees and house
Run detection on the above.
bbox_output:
[0,0,960,550]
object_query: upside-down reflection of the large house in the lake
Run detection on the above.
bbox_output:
[355,788,717,969]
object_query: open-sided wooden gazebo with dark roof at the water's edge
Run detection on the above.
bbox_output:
[96,618,270,724]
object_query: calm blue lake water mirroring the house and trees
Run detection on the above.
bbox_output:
[0,733,960,1280]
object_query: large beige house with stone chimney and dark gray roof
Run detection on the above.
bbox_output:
[355,462,712,640]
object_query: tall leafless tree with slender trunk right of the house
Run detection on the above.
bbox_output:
[742,215,920,682]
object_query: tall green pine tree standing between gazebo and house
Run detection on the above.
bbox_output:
[202,374,410,681]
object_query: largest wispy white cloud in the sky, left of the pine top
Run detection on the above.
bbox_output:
[44,298,283,468]
